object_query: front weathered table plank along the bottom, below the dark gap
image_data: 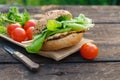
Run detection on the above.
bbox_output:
[0,63,120,80]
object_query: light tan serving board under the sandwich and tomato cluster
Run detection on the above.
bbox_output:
[0,34,93,61]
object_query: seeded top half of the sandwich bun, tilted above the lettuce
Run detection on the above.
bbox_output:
[34,10,72,34]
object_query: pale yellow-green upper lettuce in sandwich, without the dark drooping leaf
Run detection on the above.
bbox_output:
[47,14,94,31]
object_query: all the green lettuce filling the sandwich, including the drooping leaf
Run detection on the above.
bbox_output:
[26,14,94,53]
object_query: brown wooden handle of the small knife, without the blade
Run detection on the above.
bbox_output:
[13,51,39,71]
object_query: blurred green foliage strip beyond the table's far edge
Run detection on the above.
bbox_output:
[0,0,120,6]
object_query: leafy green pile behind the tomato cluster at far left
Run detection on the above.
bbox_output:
[0,7,30,34]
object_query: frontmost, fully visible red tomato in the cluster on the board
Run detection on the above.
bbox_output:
[11,28,27,42]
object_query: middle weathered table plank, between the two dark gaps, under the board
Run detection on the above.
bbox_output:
[0,24,120,63]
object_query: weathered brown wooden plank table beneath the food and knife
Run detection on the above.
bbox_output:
[0,6,120,80]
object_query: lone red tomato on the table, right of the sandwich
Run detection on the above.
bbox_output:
[80,43,98,60]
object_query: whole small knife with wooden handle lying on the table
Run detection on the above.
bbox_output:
[3,45,39,71]
